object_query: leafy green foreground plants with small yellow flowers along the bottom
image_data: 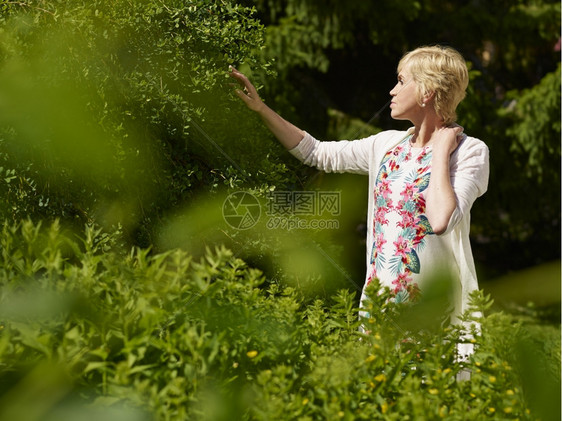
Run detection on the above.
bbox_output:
[0,221,560,421]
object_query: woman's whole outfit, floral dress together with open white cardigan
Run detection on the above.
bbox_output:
[290,127,490,334]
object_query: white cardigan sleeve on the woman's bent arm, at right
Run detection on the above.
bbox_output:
[444,138,490,234]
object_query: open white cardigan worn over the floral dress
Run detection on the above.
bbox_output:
[289,128,489,324]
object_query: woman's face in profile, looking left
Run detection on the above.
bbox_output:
[390,66,424,124]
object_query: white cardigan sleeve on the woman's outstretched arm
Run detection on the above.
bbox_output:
[289,133,376,174]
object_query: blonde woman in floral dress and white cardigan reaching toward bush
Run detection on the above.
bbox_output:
[230,46,489,342]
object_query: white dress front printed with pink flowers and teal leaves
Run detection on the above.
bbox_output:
[367,136,436,302]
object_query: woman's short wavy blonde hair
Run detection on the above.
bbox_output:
[398,45,468,125]
